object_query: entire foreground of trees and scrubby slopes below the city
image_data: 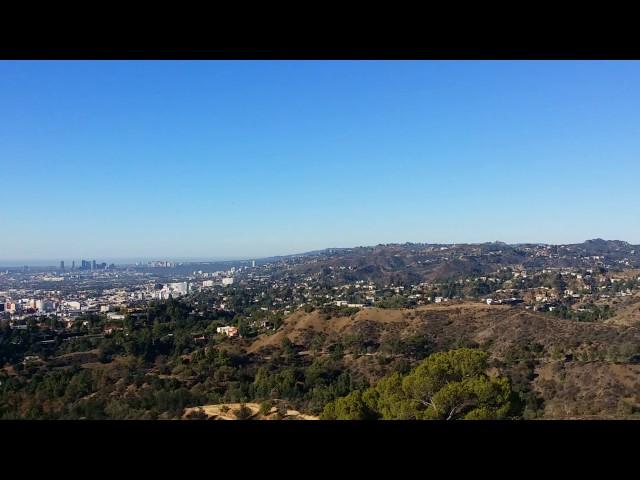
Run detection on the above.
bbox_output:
[0,277,640,419]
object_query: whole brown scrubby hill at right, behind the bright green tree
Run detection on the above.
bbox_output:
[248,303,640,418]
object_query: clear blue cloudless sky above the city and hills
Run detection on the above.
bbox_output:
[0,61,640,260]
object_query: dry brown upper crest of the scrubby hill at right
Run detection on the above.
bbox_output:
[249,302,640,357]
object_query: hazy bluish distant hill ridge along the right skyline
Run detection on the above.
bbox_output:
[260,238,640,284]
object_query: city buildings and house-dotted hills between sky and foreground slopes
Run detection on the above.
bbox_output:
[0,243,640,358]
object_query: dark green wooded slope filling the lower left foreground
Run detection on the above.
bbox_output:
[0,300,370,419]
